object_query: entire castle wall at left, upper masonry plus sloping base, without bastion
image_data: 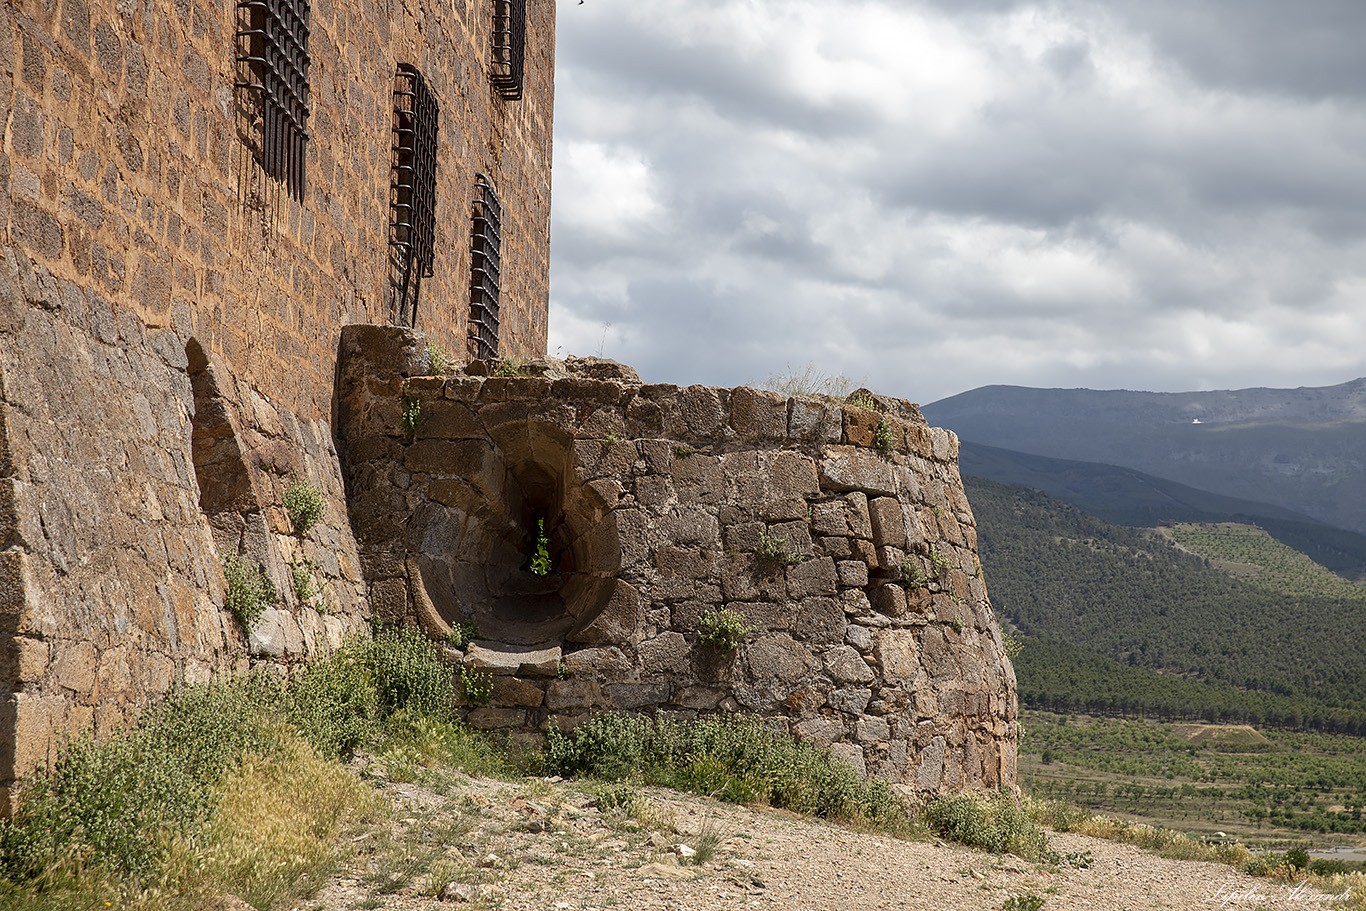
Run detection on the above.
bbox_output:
[0,0,555,815]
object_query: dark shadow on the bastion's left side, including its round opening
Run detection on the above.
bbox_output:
[337,326,623,646]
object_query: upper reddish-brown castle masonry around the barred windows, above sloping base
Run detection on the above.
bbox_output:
[0,0,555,419]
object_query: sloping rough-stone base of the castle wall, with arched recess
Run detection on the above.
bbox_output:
[0,250,369,815]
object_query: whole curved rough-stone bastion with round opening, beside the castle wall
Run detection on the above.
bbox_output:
[337,326,1019,795]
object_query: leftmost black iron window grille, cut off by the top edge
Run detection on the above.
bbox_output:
[234,0,309,202]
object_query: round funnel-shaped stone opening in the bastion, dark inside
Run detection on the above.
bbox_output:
[406,418,620,645]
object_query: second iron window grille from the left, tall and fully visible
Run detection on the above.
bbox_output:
[389,63,440,326]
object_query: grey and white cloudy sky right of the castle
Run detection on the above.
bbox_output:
[549,0,1366,403]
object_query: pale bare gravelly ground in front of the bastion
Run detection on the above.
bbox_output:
[288,776,1332,911]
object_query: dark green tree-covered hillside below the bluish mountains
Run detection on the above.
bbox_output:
[966,478,1366,731]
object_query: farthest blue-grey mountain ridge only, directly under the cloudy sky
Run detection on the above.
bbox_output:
[922,377,1366,533]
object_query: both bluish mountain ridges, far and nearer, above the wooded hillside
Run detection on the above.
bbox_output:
[922,378,1366,540]
